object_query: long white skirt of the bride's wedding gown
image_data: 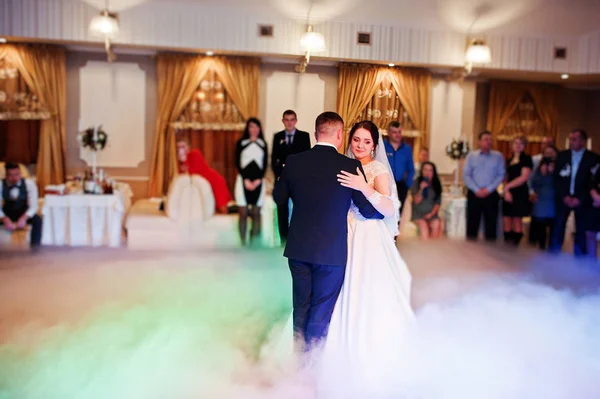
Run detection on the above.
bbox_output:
[264,215,416,399]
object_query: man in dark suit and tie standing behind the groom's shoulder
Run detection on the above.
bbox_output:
[271,109,310,243]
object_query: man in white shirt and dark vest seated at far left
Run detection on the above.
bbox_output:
[0,162,42,249]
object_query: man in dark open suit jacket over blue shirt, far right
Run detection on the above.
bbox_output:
[550,129,599,256]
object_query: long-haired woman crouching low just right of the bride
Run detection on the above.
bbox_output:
[411,161,442,240]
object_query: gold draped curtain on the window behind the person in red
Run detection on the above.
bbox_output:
[149,54,260,196]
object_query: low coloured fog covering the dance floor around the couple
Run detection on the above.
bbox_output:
[0,239,600,399]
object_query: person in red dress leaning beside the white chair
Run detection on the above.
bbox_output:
[177,140,232,213]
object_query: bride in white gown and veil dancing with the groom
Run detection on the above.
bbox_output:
[268,121,416,399]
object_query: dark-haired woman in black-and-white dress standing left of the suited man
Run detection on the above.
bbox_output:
[235,118,268,245]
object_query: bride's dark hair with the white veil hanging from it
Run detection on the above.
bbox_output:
[346,121,400,237]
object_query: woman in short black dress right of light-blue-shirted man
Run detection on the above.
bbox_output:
[502,137,533,245]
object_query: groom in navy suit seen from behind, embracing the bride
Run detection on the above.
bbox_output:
[273,112,383,350]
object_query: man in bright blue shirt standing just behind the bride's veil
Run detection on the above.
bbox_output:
[383,121,415,214]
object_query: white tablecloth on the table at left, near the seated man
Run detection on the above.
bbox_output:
[42,185,131,247]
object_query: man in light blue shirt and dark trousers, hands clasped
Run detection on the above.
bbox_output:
[463,131,506,241]
